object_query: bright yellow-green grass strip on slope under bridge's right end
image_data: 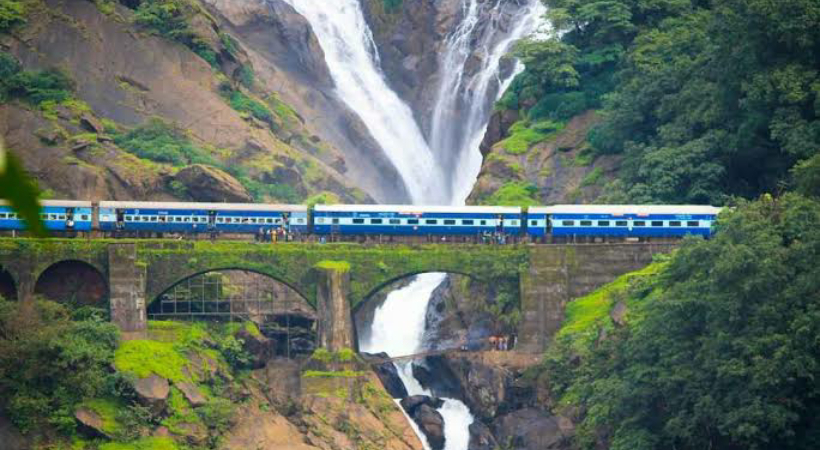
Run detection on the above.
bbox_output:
[557,262,666,342]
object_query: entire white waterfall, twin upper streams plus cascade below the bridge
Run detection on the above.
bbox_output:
[284,0,544,450]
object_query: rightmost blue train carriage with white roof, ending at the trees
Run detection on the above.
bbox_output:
[531,205,720,238]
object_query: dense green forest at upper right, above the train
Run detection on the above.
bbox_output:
[500,0,820,203]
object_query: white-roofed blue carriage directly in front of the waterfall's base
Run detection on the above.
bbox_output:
[313,205,522,236]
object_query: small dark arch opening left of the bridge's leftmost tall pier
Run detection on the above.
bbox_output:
[34,259,109,306]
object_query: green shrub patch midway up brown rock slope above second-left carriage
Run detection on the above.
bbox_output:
[114,117,218,167]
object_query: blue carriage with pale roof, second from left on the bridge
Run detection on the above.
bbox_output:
[100,202,308,233]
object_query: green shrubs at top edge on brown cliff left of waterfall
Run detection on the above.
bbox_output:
[134,0,219,67]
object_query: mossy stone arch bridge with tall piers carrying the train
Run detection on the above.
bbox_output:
[0,239,673,351]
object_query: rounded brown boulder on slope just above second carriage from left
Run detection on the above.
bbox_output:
[174,164,252,203]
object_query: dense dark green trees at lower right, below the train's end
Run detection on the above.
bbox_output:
[547,194,820,450]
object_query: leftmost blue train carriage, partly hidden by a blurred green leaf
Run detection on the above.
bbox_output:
[0,200,94,231]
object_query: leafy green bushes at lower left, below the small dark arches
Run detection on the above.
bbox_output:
[0,299,119,433]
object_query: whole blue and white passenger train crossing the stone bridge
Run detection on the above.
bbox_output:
[0,200,721,242]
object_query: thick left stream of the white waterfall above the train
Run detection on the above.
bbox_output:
[285,0,448,204]
